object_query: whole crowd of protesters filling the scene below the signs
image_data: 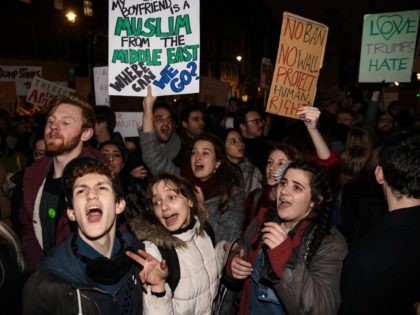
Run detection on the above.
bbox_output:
[0,87,420,315]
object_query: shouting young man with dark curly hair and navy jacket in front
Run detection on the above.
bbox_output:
[23,157,142,315]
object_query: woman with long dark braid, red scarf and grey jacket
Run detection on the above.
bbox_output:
[226,161,347,315]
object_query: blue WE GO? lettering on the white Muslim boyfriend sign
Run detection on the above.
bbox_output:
[153,61,198,93]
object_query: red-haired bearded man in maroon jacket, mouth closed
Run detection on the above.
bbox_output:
[20,96,106,270]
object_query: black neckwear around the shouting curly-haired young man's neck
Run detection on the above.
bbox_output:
[71,232,134,285]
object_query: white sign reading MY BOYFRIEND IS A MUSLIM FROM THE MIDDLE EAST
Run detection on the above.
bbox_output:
[108,0,200,96]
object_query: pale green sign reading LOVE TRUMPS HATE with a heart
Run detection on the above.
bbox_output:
[359,11,420,82]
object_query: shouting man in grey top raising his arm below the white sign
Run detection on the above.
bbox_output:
[139,86,184,175]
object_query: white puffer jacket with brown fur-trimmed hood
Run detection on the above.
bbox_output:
[130,216,225,315]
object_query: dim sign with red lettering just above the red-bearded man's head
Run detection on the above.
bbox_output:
[26,77,76,107]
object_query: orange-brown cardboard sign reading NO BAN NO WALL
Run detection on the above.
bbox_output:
[266,12,328,118]
